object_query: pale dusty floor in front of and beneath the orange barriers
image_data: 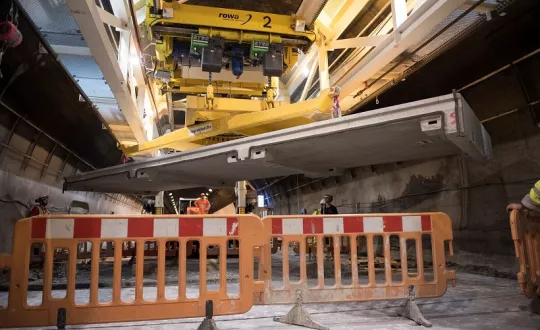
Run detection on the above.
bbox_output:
[8,273,540,330]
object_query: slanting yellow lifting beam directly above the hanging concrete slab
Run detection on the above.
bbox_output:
[124,89,332,155]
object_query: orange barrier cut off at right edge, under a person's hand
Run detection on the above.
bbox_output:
[510,211,540,314]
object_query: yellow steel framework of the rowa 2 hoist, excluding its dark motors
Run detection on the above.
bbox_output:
[131,0,335,155]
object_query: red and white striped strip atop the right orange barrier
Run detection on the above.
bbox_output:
[272,215,431,235]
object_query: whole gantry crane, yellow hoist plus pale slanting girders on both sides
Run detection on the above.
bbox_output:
[67,0,480,155]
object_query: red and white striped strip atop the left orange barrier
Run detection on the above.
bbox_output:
[32,217,239,239]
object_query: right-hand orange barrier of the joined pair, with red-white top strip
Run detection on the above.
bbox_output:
[261,213,455,304]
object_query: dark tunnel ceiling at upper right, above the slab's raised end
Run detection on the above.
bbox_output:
[357,0,540,135]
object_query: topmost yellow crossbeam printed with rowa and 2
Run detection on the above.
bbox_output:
[150,2,315,40]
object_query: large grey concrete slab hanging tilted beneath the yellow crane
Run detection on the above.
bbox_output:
[65,94,491,194]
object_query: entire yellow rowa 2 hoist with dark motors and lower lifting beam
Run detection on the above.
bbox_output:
[122,0,337,155]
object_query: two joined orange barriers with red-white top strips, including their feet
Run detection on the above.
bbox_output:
[0,213,455,329]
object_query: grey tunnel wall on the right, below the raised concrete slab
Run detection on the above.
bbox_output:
[265,111,540,274]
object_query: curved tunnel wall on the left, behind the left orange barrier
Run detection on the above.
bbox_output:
[0,118,142,253]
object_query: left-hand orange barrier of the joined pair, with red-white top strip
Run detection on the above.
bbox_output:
[0,215,265,327]
